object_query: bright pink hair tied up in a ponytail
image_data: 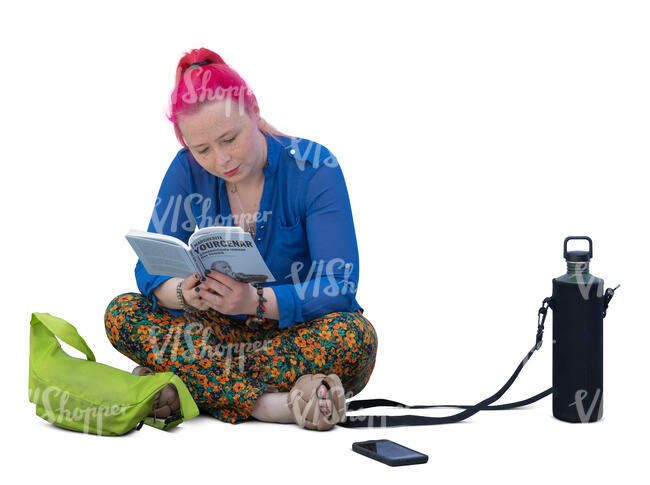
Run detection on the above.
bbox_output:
[166,47,289,148]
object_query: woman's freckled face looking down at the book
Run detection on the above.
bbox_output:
[178,99,267,183]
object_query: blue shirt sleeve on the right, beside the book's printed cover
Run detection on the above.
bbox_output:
[272,154,359,328]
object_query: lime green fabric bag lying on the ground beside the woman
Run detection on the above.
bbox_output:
[29,313,199,436]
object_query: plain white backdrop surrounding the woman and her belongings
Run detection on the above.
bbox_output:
[0,0,650,483]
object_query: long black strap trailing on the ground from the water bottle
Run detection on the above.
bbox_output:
[337,298,553,428]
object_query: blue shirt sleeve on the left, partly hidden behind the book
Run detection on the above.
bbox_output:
[135,152,196,316]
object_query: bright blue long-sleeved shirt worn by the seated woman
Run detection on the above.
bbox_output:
[135,133,363,328]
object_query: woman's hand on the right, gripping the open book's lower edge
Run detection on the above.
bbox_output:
[197,269,257,315]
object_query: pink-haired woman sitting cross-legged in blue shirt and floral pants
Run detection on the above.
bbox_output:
[104,49,377,430]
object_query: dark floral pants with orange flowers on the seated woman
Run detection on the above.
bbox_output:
[104,293,377,423]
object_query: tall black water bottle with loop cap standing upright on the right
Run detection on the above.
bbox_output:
[550,236,609,423]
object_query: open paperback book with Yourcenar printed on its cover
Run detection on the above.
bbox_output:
[125,226,275,283]
